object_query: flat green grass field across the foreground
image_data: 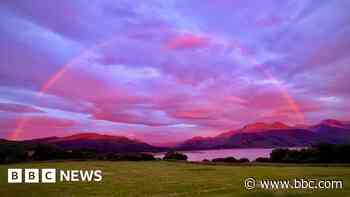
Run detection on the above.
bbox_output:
[0,161,350,197]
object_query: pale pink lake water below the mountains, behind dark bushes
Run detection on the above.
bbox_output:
[154,148,273,161]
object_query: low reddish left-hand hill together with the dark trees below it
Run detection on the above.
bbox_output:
[0,133,168,164]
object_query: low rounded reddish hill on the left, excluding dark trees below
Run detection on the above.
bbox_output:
[26,133,165,153]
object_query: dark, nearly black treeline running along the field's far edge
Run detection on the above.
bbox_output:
[0,142,350,164]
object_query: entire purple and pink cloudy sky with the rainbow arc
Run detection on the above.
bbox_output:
[0,0,350,144]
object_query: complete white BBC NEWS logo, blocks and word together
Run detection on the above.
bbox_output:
[7,168,102,183]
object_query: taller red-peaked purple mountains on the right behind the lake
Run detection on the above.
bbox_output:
[177,120,350,150]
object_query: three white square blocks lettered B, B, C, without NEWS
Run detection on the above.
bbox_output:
[7,168,56,183]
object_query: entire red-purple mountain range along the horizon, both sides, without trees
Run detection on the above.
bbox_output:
[0,119,350,153]
